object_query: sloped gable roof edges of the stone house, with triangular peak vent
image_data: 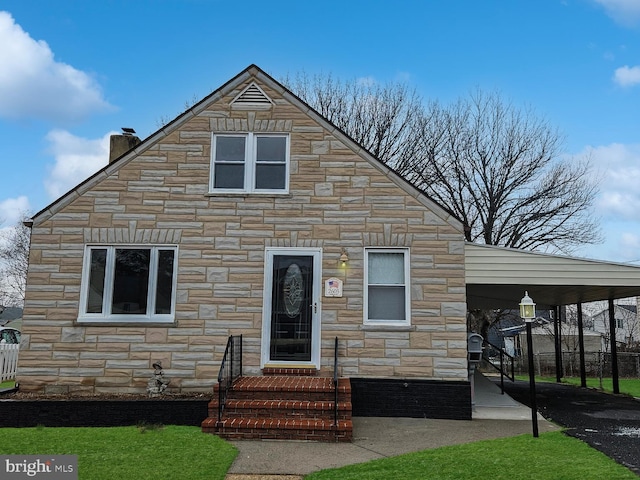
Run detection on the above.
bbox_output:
[32,65,464,232]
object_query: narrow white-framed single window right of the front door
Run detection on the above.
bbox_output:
[364,248,411,325]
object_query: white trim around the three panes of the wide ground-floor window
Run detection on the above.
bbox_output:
[78,244,178,325]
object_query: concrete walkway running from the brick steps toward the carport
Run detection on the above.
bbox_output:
[227,375,559,480]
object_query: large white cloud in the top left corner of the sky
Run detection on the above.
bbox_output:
[0,11,112,121]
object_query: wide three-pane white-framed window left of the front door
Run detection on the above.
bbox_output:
[78,245,178,323]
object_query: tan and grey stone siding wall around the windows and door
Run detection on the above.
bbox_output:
[18,75,467,394]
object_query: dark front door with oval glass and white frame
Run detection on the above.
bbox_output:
[263,249,320,368]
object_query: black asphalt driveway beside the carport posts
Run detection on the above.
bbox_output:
[505,381,640,475]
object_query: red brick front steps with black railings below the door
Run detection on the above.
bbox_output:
[202,375,353,442]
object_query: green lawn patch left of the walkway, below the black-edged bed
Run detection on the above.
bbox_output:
[0,426,237,480]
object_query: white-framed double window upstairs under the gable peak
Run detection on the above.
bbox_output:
[209,133,289,193]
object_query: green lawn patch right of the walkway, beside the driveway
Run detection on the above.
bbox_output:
[305,432,638,480]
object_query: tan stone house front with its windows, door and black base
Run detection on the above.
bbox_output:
[17,66,471,418]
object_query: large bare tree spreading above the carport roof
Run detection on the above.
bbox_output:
[395,92,601,253]
